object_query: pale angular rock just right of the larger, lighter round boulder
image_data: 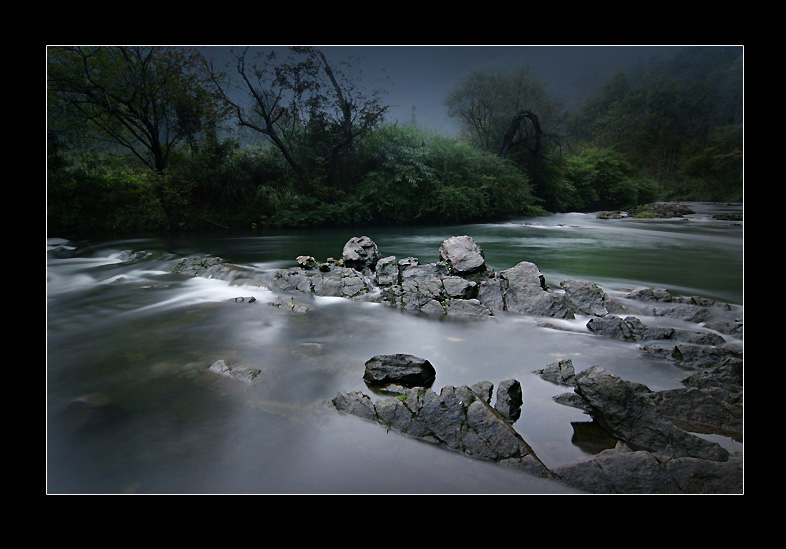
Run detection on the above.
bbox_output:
[500,261,575,318]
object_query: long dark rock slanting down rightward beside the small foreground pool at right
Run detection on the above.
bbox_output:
[574,366,729,461]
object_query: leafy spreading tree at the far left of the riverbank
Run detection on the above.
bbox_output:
[48,46,225,173]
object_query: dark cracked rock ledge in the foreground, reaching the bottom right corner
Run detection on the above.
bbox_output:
[324,355,743,494]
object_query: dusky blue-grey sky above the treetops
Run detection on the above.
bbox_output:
[205,44,679,135]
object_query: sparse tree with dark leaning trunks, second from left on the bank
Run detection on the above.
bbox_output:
[214,47,387,193]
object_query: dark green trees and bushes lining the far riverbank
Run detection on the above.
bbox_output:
[47,47,742,235]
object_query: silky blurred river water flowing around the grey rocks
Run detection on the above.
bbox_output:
[46,204,743,494]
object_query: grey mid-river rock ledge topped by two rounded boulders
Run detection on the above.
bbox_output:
[173,232,743,369]
